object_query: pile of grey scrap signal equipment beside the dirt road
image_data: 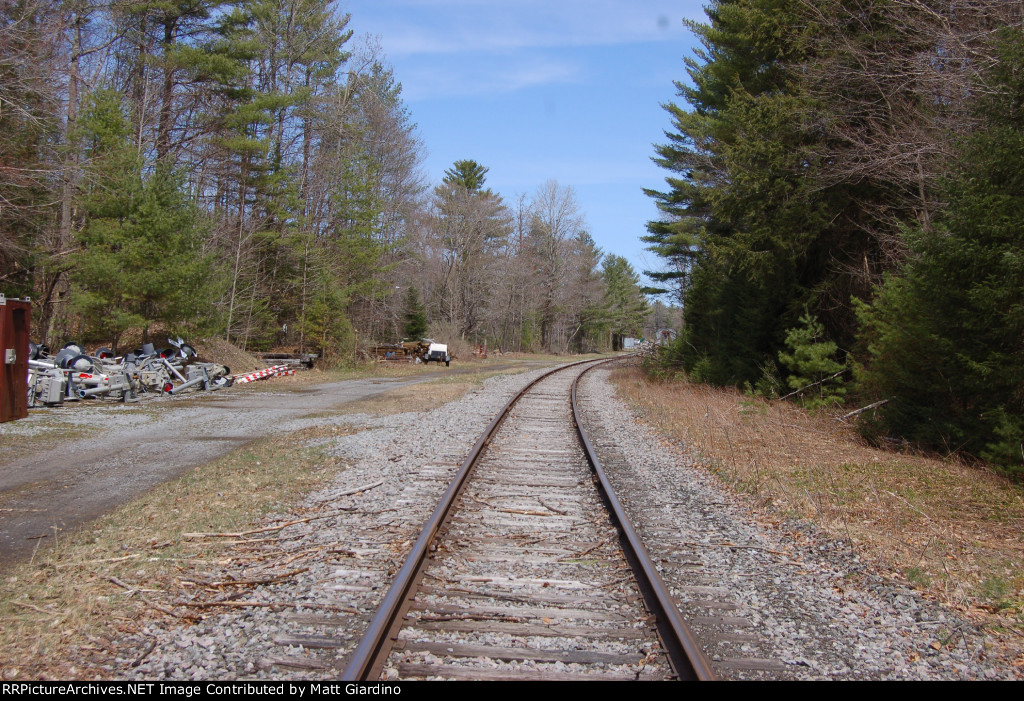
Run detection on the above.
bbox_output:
[29,339,237,406]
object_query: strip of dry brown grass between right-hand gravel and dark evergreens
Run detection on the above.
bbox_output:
[613,367,1024,650]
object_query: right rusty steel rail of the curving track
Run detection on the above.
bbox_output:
[571,358,716,682]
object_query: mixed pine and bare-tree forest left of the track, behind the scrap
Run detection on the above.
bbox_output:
[0,0,651,360]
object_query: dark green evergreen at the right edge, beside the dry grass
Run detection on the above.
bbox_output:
[862,29,1024,471]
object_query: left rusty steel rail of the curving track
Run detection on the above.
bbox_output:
[341,360,594,682]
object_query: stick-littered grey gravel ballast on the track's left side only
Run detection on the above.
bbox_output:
[117,370,561,680]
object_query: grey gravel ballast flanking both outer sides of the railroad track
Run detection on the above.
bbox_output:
[109,360,1015,681]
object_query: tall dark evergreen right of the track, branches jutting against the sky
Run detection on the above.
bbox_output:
[644,0,853,384]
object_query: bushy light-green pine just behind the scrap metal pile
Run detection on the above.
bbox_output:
[72,91,214,345]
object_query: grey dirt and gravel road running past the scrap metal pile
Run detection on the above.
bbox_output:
[0,361,544,565]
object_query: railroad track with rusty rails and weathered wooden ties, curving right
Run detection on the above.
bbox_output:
[343,362,713,681]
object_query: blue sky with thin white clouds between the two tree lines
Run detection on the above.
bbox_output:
[341,0,705,284]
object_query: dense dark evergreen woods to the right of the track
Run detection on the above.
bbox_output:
[644,0,1024,475]
